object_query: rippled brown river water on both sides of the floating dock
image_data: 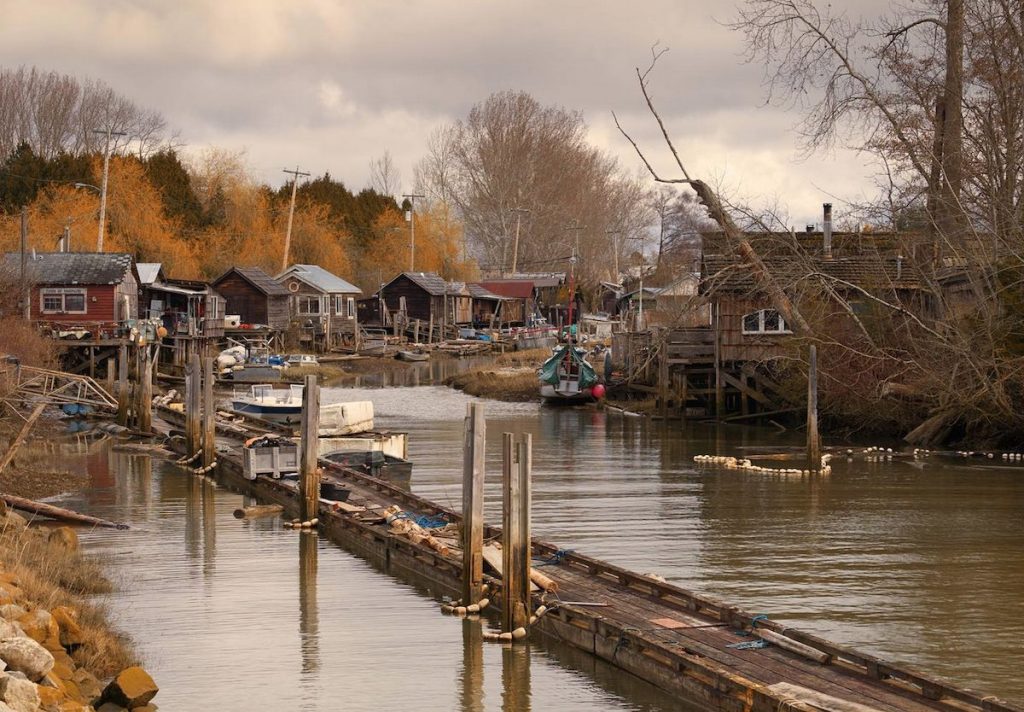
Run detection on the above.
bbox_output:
[51,373,1024,710]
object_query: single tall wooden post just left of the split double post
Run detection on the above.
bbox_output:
[462,403,487,605]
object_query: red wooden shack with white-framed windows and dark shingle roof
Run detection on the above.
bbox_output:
[6,252,139,338]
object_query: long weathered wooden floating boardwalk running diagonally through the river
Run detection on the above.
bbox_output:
[160,409,1024,712]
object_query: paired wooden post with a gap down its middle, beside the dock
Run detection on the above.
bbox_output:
[502,432,530,632]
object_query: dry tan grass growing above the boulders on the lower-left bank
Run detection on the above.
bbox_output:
[0,518,138,679]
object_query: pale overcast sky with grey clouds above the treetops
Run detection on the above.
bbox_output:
[0,0,888,225]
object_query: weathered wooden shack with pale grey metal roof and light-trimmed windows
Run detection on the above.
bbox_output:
[274,264,362,351]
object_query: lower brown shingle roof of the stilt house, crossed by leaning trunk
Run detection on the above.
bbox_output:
[700,255,922,294]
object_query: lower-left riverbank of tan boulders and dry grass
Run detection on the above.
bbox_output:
[0,503,159,712]
